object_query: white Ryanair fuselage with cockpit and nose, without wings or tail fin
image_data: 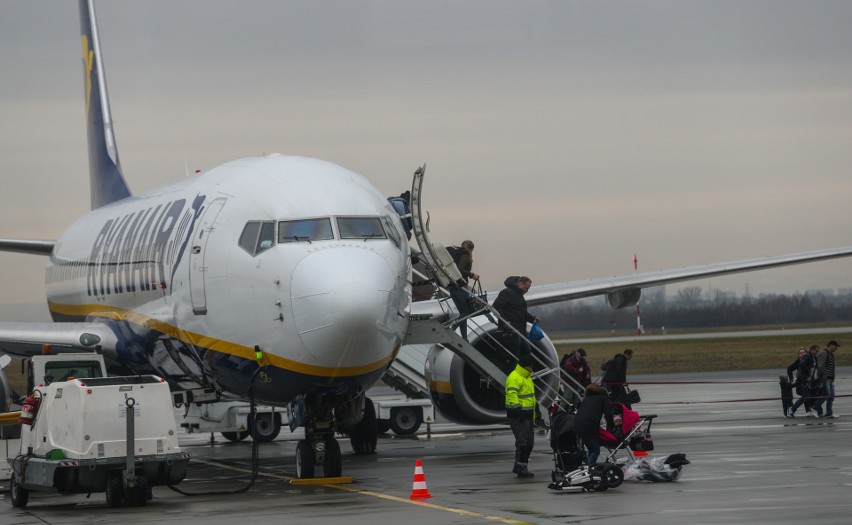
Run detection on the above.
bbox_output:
[46,155,411,404]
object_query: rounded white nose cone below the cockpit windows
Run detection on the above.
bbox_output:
[290,247,399,367]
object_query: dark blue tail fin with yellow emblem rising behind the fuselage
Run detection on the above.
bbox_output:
[80,0,130,209]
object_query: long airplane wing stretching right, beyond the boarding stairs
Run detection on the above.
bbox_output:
[411,246,852,314]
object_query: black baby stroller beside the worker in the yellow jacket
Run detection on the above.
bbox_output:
[548,404,624,492]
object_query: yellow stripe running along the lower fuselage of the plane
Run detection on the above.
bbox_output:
[48,302,392,378]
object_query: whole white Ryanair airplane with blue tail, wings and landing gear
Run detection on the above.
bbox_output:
[0,0,852,477]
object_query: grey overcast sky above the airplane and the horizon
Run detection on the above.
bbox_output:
[0,0,852,303]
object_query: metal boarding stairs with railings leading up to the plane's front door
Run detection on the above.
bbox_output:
[384,166,582,408]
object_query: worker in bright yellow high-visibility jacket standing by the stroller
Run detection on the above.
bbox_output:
[506,354,536,478]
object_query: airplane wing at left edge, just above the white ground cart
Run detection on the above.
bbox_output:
[0,322,118,357]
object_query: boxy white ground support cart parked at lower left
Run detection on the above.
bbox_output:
[8,375,189,508]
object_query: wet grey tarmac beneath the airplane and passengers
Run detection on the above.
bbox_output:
[0,368,852,525]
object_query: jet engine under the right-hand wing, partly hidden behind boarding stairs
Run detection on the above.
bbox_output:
[425,318,559,425]
